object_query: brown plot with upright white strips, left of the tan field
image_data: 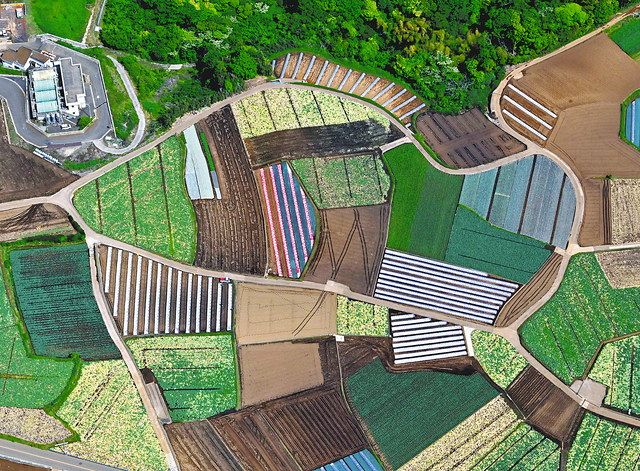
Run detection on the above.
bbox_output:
[98,245,233,337]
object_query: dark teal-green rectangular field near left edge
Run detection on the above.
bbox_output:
[10,244,120,360]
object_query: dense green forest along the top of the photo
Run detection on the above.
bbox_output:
[101,0,631,126]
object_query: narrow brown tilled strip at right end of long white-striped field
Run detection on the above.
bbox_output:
[495,252,562,327]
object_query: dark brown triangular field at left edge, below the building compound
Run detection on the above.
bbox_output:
[0,107,78,203]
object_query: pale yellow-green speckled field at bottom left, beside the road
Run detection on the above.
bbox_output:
[55,360,167,471]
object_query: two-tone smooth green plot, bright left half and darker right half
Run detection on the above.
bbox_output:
[384,144,464,260]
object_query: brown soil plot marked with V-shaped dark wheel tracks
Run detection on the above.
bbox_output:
[305,204,389,295]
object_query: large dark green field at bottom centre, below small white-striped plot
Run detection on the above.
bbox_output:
[347,360,498,469]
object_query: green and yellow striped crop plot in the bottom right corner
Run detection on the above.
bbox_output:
[567,413,640,471]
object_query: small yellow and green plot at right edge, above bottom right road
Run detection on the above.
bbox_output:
[589,336,640,415]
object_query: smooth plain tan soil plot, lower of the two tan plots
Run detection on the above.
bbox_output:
[238,342,324,407]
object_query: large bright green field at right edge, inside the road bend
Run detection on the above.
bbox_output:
[520,254,640,384]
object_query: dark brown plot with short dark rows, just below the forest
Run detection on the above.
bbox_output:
[416,108,527,168]
